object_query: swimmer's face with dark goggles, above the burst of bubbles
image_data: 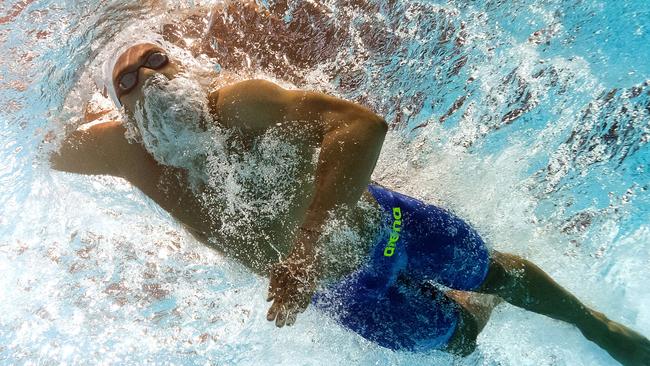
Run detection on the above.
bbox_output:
[113,43,180,113]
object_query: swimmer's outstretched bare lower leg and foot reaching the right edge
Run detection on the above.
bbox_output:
[476,251,650,365]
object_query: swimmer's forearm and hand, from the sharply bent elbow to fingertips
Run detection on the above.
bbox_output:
[266,87,388,327]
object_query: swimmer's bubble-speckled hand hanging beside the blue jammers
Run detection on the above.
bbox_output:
[266,230,319,327]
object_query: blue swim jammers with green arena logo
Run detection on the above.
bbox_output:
[312,185,489,352]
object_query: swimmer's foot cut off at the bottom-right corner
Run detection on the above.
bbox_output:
[582,311,650,366]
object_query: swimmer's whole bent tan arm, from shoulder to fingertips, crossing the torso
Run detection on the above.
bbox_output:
[215,80,388,327]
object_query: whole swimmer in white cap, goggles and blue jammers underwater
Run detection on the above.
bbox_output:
[51,43,650,365]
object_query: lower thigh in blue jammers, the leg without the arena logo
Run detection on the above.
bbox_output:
[312,271,459,352]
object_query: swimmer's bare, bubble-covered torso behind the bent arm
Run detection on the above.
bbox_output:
[111,120,379,279]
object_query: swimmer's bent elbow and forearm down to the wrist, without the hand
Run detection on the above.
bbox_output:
[295,92,388,231]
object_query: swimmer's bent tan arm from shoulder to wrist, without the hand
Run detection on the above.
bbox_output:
[210,80,388,231]
